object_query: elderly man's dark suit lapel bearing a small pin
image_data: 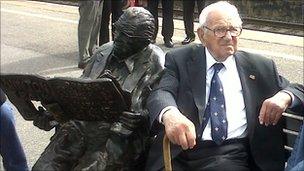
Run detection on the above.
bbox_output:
[235,52,259,138]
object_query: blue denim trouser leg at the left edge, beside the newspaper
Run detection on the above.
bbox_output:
[0,102,28,171]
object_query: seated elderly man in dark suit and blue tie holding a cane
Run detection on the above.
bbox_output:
[146,1,304,171]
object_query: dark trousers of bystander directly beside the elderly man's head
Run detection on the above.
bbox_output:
[183,0,205,37]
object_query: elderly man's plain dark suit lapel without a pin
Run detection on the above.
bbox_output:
[187,45,206,129]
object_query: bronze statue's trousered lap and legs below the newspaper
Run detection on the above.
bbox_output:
[32,120,145,171]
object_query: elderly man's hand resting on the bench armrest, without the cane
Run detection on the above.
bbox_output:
[259,91,292,126]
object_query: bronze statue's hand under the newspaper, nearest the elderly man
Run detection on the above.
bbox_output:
[111,111,144,136]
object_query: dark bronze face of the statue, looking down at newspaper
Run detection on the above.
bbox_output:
[113,31,147,59]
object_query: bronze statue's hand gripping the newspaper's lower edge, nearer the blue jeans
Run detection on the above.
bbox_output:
[33,106,58,131]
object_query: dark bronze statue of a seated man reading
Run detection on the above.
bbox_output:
[33,7,164,171]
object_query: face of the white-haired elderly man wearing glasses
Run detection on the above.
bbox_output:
[198,11,240,62]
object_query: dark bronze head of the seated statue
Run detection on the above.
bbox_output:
[113,7,155,58]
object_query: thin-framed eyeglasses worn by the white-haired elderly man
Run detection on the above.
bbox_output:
[203,26,242,38]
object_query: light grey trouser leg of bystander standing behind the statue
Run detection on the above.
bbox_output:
[78,0,103,63]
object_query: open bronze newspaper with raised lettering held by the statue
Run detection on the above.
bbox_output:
[0,74,130,122]
